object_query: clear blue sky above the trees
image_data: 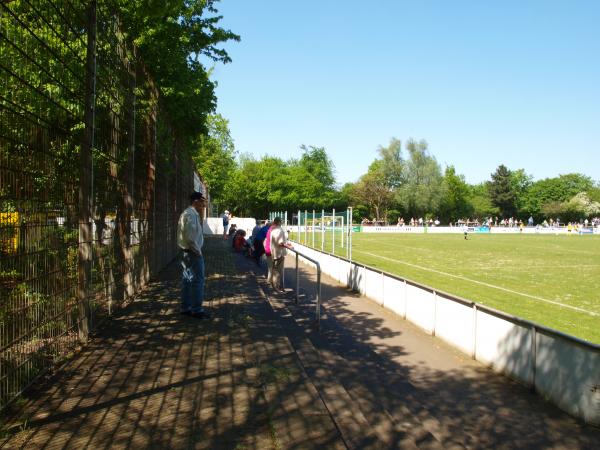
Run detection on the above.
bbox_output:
[207,0,600,184]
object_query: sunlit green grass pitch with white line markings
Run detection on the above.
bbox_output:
[291,233,600,344]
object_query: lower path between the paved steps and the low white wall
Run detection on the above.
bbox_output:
[248,251,600,449]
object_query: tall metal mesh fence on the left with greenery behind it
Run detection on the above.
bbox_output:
[0,0,194,409]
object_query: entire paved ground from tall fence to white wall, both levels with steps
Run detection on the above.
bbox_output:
[2,239,600,450]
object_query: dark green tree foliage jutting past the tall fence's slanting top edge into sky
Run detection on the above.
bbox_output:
[118,0,240,145]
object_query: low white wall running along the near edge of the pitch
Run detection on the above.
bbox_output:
[294,243,600,425]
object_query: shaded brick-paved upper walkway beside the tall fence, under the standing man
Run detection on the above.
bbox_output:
[1,239,346,450]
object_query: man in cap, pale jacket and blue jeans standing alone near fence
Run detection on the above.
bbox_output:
[177,192,208,319]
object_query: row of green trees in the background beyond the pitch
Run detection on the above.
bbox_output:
[195,120,600,224]
